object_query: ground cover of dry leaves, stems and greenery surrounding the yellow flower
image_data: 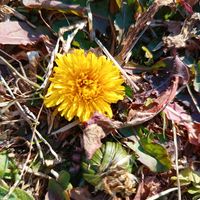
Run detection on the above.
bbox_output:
[0,0,200,200]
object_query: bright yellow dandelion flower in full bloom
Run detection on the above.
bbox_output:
[44,50,124,122]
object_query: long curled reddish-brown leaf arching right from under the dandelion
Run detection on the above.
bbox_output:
[89,56,189,132]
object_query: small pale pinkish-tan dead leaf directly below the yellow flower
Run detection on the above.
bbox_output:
[83,124,106,159]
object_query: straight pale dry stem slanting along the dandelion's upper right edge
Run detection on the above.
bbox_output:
[94,37,140,92]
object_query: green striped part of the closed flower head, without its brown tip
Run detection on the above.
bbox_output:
[82,142,132,189]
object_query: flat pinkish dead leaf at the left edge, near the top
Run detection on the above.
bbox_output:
[0,21,42,45]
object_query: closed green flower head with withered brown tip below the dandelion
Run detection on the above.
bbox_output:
[82,142,137,197]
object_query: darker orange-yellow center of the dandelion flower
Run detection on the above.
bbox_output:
[76,73,100,100]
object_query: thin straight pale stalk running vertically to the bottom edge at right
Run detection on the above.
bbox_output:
[172,121,181,200]
